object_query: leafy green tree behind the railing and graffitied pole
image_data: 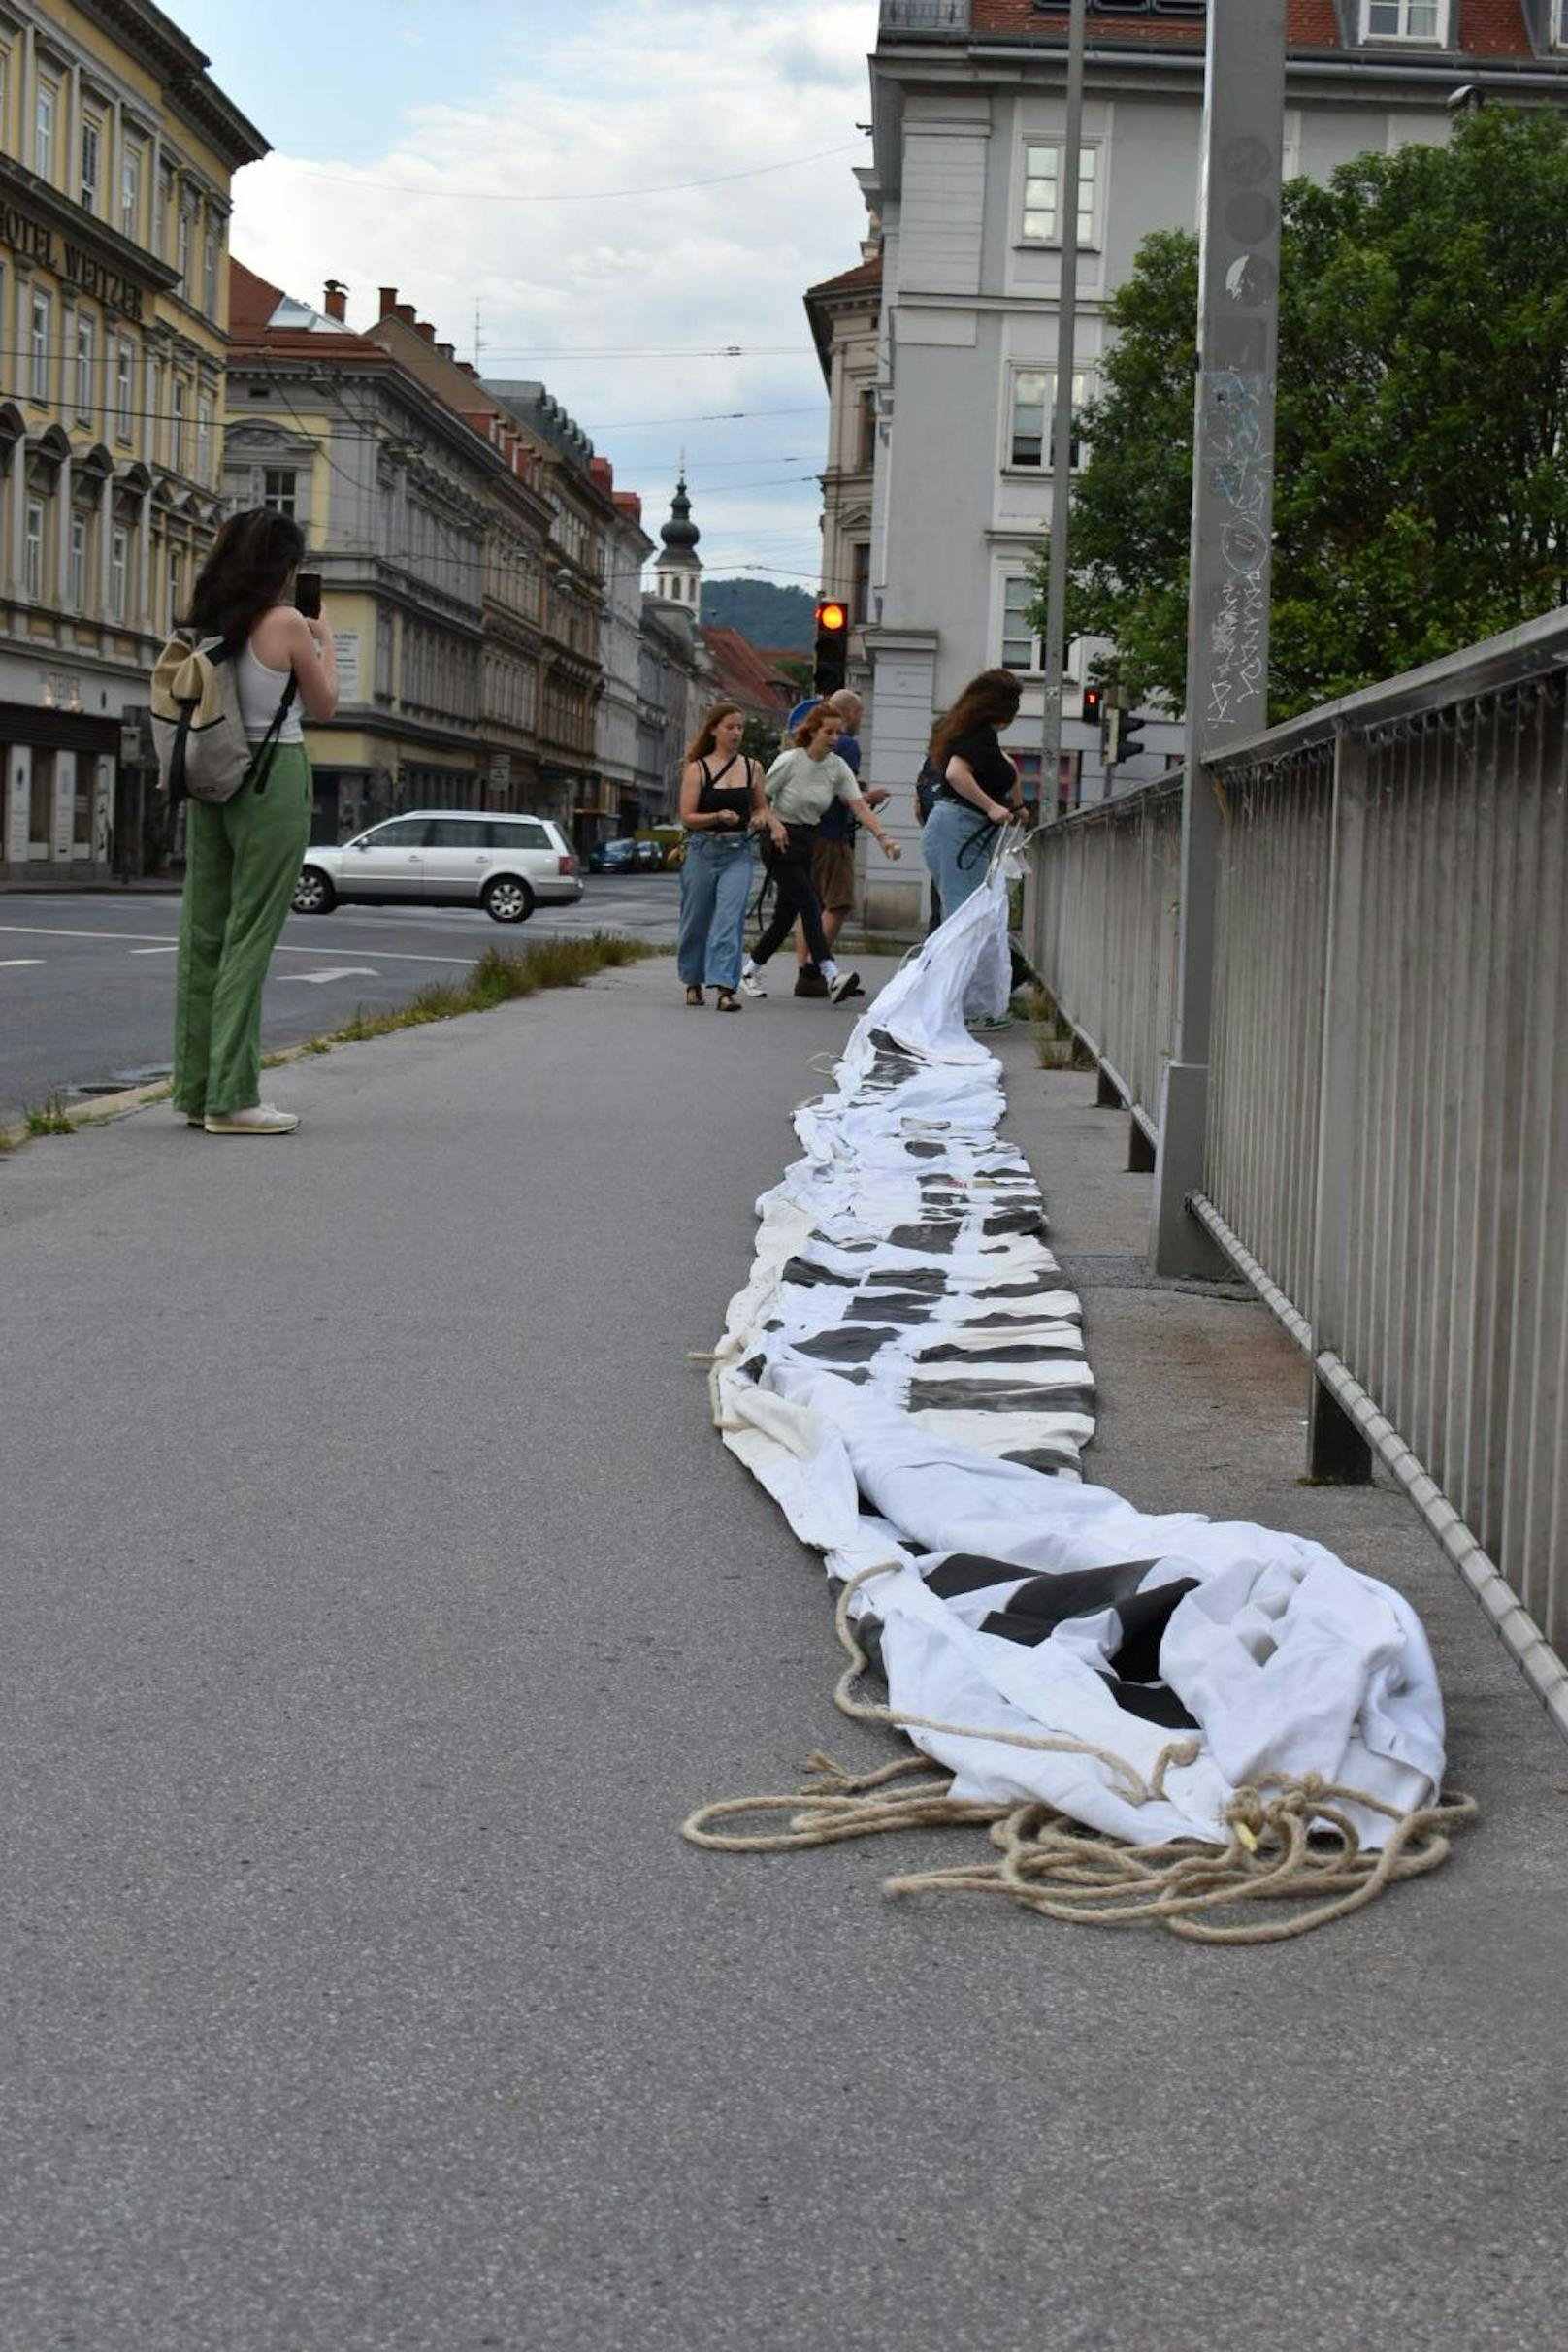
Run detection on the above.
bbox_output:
[1036,106,1568,717]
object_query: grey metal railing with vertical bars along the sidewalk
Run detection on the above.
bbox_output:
[1041,611,1568,1693]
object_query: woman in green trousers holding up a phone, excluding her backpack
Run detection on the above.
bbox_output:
[174,506,339,1136]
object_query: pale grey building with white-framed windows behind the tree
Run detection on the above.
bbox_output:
[858,0,1568,927]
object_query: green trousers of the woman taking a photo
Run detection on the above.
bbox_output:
[174,743,310,1120]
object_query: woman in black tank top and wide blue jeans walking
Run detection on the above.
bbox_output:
[674,703,783,1014]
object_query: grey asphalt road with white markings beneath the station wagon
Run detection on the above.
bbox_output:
[0,875,679,1127]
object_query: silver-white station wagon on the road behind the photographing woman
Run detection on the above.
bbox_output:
[294,809,583,922]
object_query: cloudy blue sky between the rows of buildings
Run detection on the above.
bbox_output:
[165,0,877,588]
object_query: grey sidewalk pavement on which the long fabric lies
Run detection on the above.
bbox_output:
[0,964,1568,2352]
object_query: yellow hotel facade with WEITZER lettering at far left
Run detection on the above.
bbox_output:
[0,0,266,884]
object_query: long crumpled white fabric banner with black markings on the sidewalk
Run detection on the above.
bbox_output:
[715,875,1444,1846]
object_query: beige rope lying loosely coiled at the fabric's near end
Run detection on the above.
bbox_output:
[682,1561,1477,1943]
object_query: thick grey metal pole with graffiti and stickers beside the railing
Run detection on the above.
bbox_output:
[1150,0,1286,1275]
